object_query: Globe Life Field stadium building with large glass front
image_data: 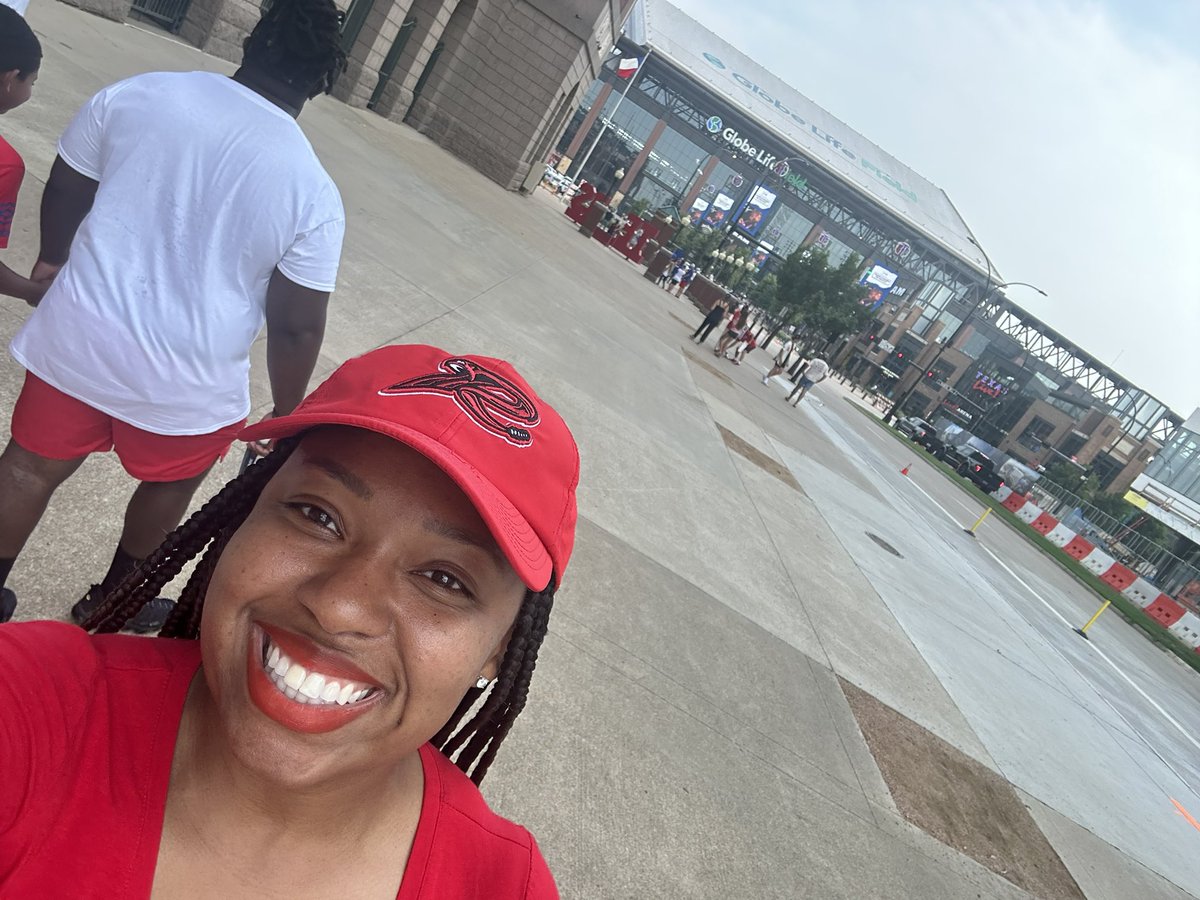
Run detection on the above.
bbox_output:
[550,0,1181,475]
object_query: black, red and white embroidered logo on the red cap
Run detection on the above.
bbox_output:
[379,356,540,448]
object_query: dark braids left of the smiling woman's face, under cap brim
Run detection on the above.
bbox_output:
[83,440,295,637]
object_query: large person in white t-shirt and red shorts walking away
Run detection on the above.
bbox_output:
[0,0,346,630]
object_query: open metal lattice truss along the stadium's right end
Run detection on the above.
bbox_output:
[977,300,1183,443]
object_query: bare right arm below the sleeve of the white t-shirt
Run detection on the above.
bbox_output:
[266,269,329,415]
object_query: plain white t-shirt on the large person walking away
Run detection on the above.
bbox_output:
[12,72,346,434]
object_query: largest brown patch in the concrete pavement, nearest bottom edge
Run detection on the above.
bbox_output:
[838,678,1084,900]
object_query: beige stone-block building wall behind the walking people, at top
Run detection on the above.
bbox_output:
[64,0,632,190]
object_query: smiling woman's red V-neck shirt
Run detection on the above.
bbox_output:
[0,622,558,900]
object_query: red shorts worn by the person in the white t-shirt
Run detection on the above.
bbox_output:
[12,372,245,481]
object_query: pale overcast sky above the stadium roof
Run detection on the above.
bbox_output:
[673,0,1200,418]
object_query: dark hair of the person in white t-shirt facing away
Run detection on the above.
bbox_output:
[242,0,346,100]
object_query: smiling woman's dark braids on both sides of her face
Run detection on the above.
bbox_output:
[83,437,556,785]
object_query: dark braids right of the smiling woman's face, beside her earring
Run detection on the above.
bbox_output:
[432,581,554,785]
